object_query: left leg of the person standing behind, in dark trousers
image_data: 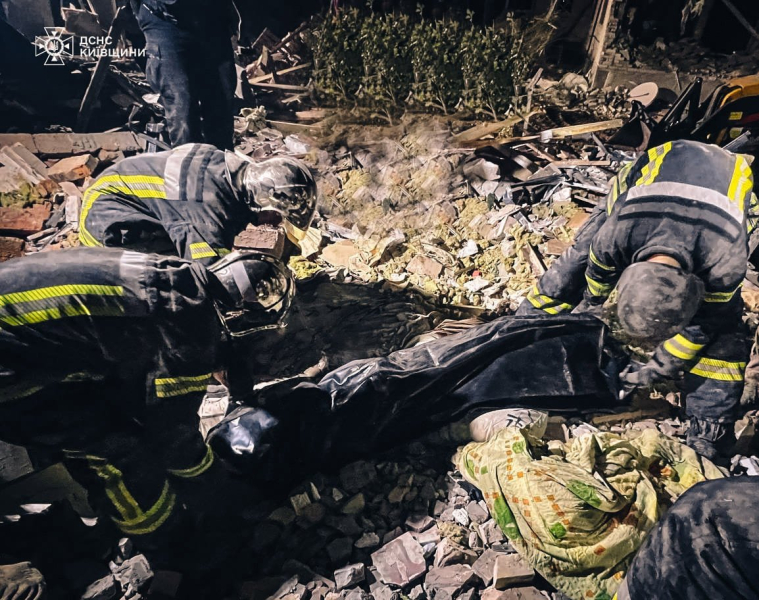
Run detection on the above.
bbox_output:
[137,4,203,146]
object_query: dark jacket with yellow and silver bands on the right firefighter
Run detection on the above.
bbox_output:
[519,141,756,436]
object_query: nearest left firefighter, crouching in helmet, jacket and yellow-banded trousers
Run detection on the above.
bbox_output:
[0,248,294,568]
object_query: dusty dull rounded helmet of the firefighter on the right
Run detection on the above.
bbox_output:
[617,262,704,343]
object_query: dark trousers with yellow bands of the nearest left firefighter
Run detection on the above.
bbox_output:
[0,380,216,552]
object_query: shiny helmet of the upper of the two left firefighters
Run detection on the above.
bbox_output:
[227,152,316,244]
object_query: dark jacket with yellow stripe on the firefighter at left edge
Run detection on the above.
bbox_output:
[0,248,224,409]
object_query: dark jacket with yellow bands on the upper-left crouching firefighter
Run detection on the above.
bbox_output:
[79,144,250,265]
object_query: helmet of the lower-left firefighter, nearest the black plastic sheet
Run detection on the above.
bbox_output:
[208,252,295,337]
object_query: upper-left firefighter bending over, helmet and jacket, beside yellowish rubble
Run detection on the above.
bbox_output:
[79,144,316,265]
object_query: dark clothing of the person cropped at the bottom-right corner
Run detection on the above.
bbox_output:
[616,477,759,600]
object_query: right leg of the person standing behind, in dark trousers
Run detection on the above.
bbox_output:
[193,32,237,150]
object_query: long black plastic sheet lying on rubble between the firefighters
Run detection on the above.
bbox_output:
[212,315,619,476]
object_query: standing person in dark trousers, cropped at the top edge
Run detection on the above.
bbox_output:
[132,0,240,149]
